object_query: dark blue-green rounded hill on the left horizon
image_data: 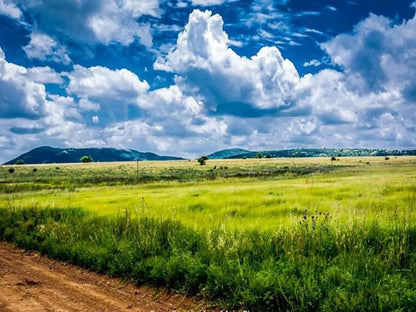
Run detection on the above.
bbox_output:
[5,146,183,165]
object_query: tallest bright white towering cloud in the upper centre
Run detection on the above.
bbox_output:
[155,10,299,112]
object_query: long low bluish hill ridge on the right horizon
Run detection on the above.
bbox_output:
[224,148,416,159]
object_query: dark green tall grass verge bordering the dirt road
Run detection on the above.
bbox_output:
[0,208,416,311]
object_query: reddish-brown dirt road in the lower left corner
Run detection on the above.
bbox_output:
[0,242,214,312]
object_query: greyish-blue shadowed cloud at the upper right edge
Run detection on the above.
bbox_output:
[322,14,416,102]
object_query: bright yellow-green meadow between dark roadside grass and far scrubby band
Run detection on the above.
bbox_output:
[0,163,416,231]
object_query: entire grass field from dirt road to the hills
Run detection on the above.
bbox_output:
[0,157,416,311]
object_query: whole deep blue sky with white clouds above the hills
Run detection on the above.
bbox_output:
[0,0,416,162]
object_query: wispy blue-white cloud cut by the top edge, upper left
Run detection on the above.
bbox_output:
[20,0,160,47]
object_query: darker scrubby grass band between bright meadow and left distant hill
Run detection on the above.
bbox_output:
[0,161,336,194]
